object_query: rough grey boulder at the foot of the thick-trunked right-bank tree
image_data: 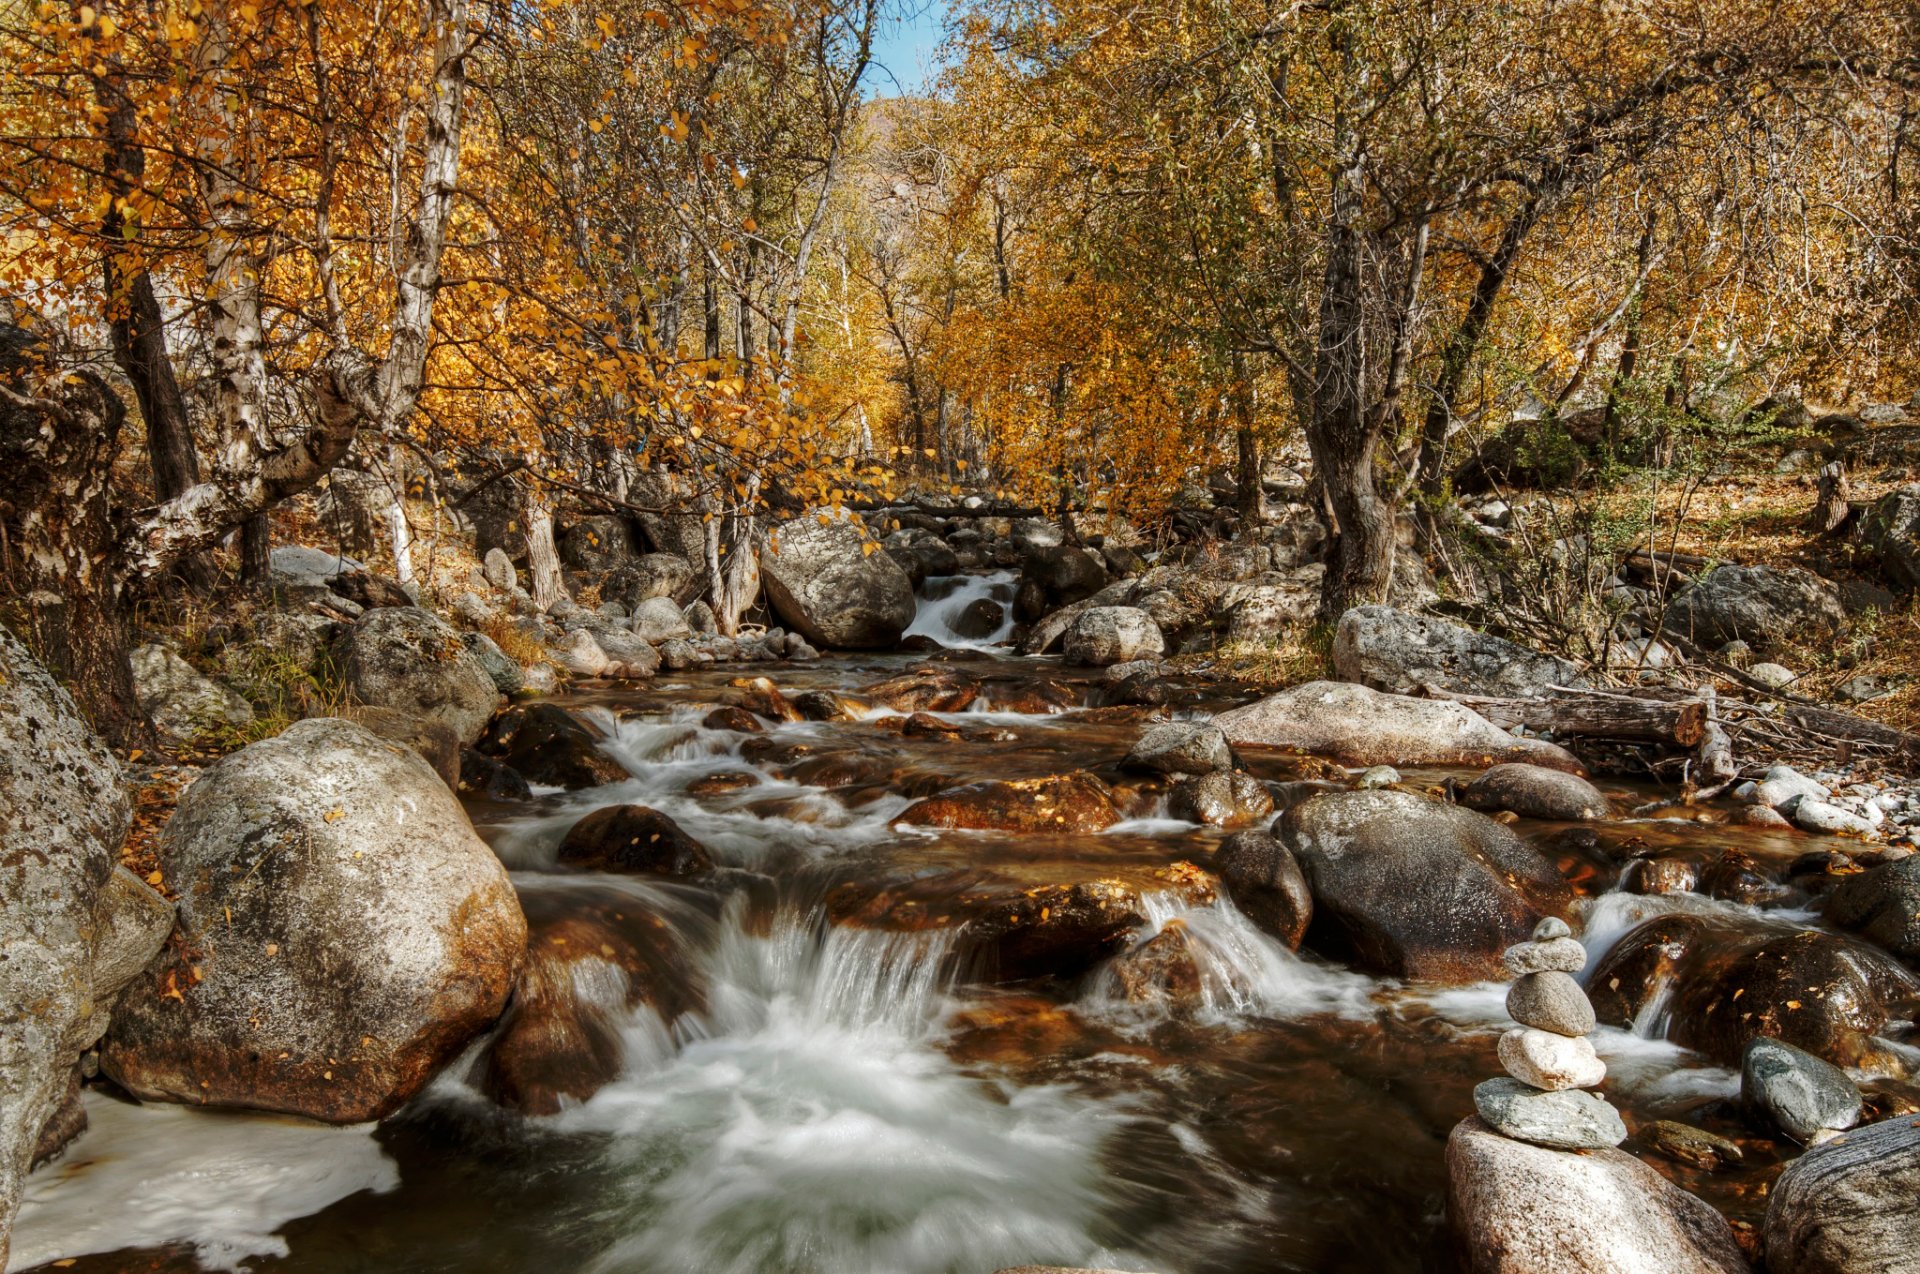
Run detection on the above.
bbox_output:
[1332,606,1586,698]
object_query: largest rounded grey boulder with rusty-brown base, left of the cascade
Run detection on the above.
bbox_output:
[100,718,526,1122]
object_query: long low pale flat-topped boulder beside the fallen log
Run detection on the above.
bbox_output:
[1213,681,1580,773]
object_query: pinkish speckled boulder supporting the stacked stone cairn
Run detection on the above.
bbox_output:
[1446,1119,1747,1274]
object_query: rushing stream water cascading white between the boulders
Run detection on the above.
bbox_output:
[10,578,1904,1274]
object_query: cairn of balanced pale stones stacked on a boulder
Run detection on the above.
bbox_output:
[1473,915,1626,1149]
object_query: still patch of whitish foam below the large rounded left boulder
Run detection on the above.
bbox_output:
[6,1094,399,1270]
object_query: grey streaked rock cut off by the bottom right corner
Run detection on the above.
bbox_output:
[1764,1117,1920,1274]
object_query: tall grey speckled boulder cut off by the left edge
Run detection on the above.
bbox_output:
[0,627,173,1268]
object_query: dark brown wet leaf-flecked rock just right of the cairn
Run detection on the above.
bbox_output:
[1586,915,1920,1067]
